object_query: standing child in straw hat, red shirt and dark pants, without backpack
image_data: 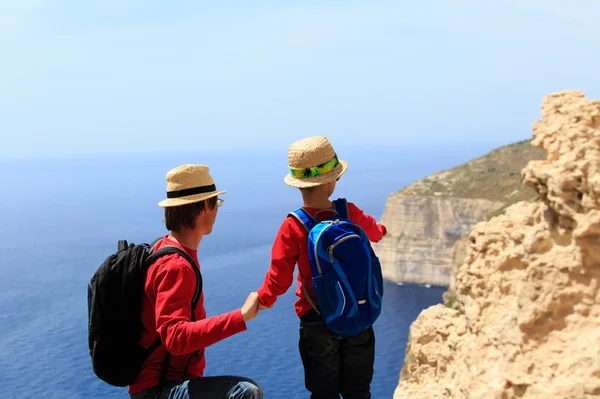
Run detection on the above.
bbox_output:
[257,136,387,399]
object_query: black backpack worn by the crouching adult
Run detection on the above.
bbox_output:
[88,237,202,387]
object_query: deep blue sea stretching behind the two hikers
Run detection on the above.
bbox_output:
[0,144,494,399]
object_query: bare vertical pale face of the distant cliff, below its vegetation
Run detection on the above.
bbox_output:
[373,194,503,285]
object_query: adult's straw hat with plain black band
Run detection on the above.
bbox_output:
[158,164,225,208]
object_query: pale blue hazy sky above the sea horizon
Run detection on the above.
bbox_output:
[0,0,600,156]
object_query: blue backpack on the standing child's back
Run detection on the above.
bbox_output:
[290,198,383,336]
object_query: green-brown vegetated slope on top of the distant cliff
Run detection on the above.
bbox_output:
[399,140,546,214]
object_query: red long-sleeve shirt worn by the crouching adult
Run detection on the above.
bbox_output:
[129,236,246,394]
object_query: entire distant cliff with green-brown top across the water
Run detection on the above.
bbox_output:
[373,141,544,286]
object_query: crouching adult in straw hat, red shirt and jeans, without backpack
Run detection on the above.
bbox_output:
[129,165,263,399]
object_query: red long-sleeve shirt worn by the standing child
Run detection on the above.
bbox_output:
[257,202,387,317]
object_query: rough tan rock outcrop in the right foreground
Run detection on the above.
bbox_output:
[394,91,600,399]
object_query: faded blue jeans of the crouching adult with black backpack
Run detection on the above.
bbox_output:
[131,376,263,399]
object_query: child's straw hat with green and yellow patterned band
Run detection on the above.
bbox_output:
[284,136,348,188]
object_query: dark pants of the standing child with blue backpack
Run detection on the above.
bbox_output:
[298,311,375,399]
